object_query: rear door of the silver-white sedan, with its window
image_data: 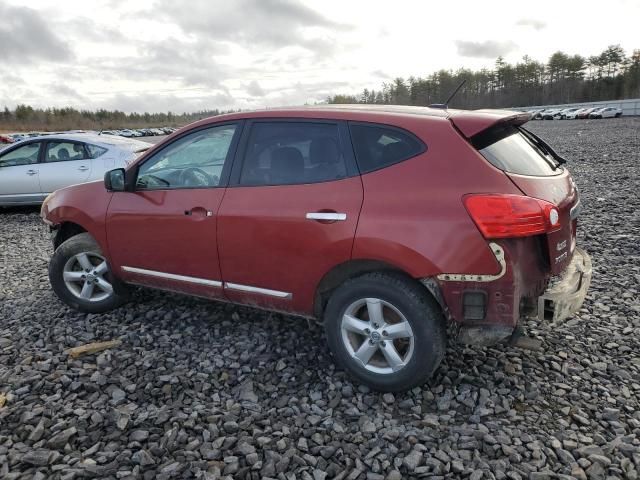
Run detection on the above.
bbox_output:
[39,140,92,195]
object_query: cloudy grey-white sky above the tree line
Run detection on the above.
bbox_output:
[0,0,640,113]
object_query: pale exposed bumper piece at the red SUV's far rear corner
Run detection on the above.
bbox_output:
[538,248,591,323]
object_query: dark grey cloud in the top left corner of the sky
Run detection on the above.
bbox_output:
[0,3,73,64]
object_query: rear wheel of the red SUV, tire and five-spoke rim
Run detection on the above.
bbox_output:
[324,272,446,392]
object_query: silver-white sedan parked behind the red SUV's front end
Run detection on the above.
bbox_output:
[0,133,151,206]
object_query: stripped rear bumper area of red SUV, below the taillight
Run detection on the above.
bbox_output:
[438,241,591,345]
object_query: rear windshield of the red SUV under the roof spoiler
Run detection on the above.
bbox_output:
[472,125,562,177]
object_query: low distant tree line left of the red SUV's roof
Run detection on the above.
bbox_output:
[0,105,238,132]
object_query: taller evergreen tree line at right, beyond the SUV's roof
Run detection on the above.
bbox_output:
[327,45,640,109]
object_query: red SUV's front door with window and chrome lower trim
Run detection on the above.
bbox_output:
[106,123,241,298]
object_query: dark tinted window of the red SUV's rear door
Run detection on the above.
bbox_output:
[240,122,347,186]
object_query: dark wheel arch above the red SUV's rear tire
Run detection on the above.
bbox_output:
[313,259,442,320]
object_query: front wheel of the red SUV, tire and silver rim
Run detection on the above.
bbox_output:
[49,233,125,313]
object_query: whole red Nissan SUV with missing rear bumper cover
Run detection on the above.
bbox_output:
[42,106,591,391]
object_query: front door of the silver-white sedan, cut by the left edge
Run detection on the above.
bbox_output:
[0,142,44,205]
